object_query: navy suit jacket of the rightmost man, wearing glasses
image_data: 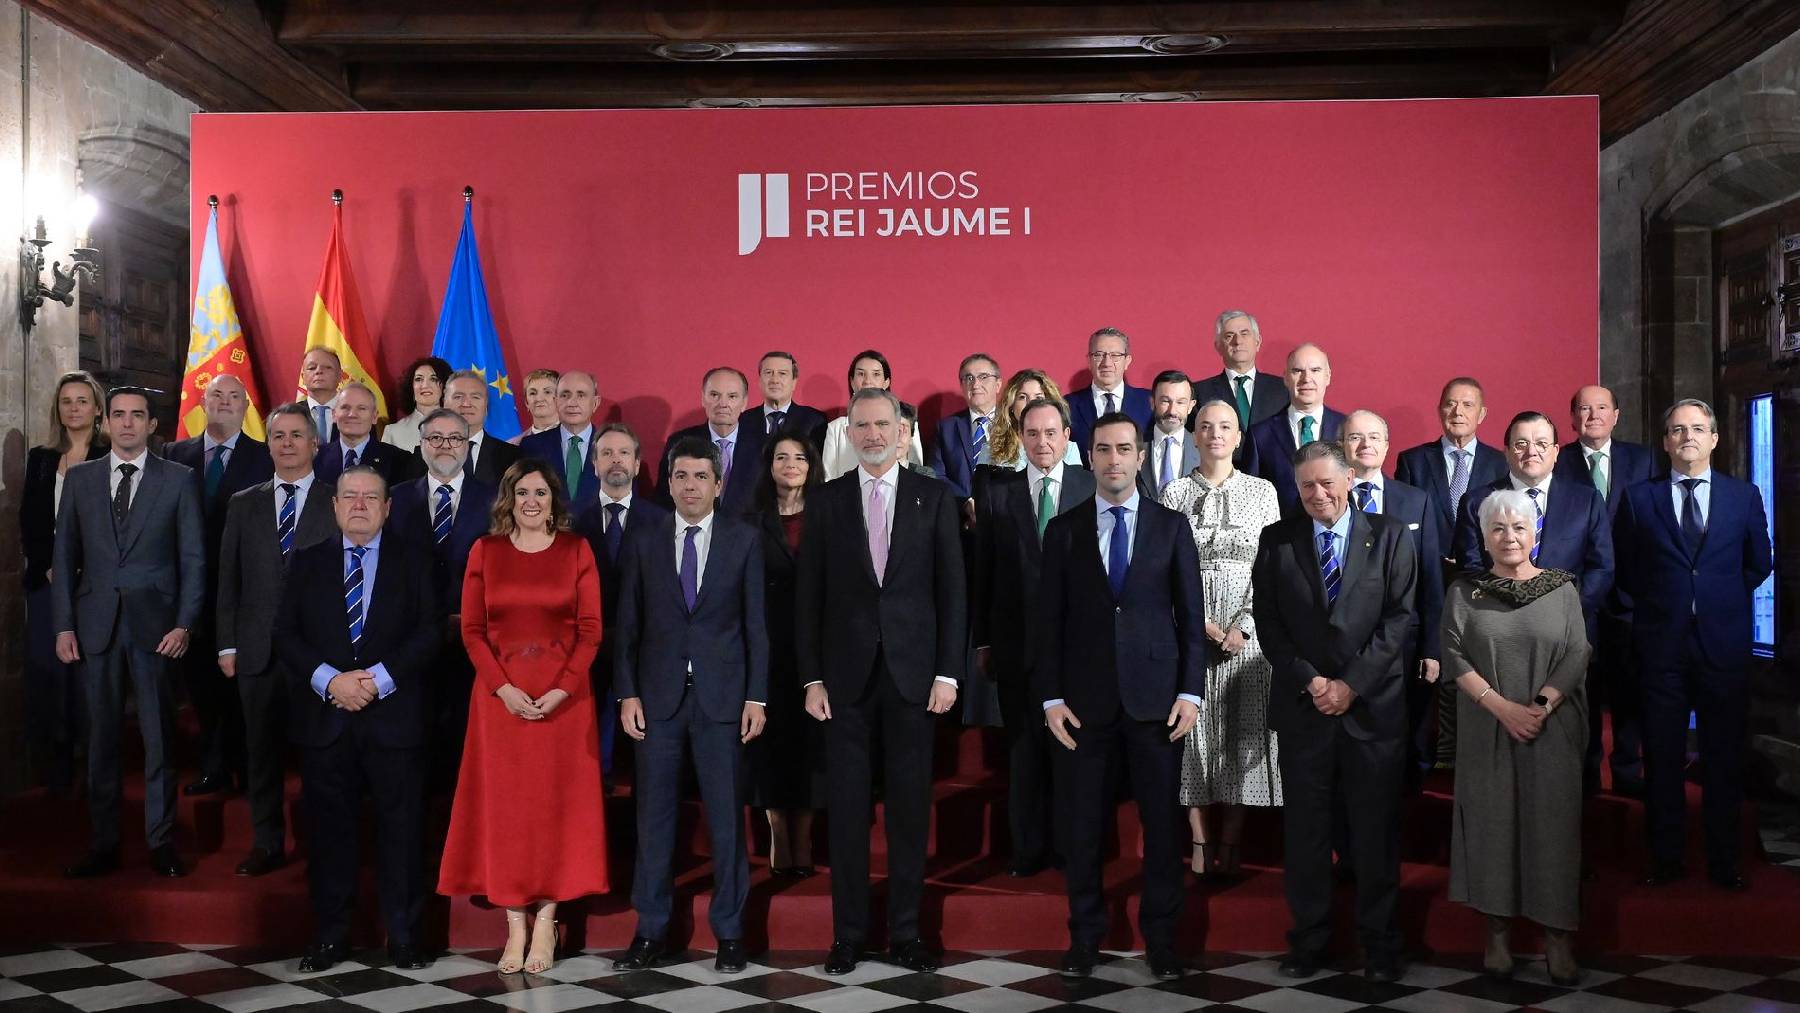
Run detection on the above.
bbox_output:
[1616,471,1775,669]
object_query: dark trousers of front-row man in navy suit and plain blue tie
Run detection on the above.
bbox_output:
[1039,704,1183,950]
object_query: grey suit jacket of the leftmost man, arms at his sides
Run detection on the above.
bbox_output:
[50,453,207,655]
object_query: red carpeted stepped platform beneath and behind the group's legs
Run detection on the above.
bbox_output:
[0,729,1800,955]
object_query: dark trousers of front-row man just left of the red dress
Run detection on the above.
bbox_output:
[301,722,428,945]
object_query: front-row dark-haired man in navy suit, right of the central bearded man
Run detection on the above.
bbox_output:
[1031,412,1206,979]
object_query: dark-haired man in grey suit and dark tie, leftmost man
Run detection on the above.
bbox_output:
[50,387,207,878]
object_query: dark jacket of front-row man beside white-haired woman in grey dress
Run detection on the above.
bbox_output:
[1251,506,1418,740]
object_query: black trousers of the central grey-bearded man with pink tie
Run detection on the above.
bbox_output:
[824,653,936,945]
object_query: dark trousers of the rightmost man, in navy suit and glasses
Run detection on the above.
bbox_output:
[1640,621,1750,876]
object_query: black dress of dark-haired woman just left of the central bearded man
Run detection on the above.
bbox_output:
[749,511,824,810]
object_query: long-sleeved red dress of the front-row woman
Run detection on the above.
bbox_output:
[437,533,608,907]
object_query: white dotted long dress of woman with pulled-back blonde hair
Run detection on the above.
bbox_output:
[1163,471,1282,806]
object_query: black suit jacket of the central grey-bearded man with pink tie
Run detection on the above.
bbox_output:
[794,468,968,704]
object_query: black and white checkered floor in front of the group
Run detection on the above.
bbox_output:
[0,943,1800,1013]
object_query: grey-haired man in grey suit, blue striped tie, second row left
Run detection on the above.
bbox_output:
[214,403,338,876]
